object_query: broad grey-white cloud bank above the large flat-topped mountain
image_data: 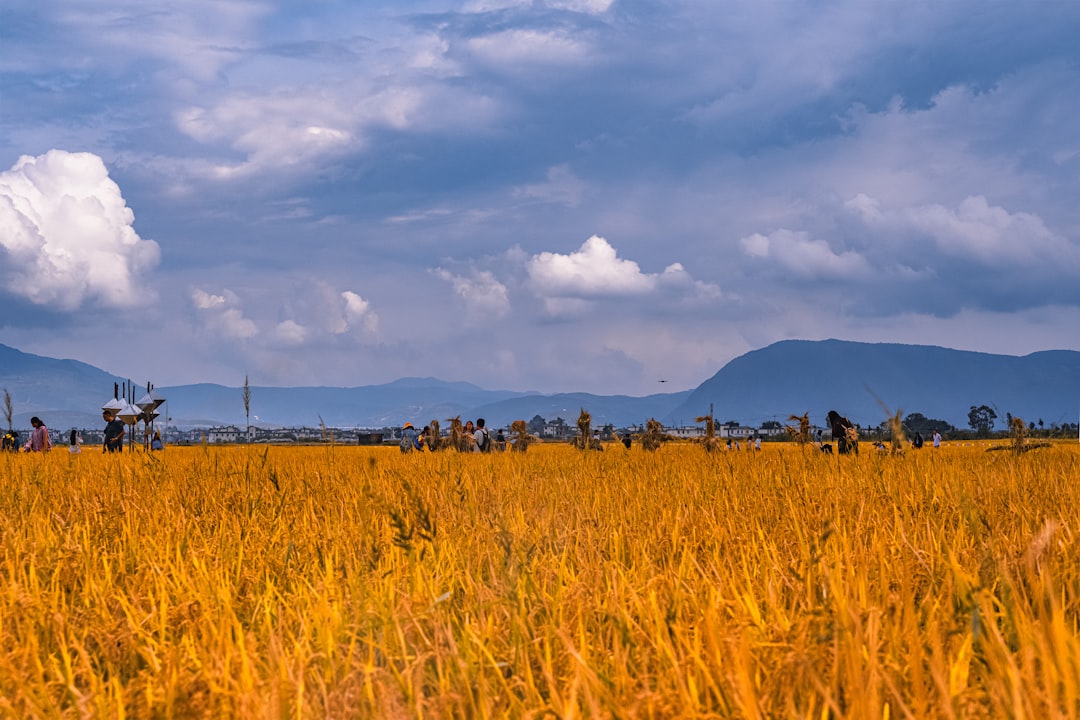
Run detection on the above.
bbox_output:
[740,193,1080,316]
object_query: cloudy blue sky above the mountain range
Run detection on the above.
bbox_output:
[0,0,1080,395]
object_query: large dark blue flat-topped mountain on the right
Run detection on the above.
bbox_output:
[675,340,1080,427]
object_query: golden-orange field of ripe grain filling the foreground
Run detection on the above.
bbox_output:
[0,441,1080,719]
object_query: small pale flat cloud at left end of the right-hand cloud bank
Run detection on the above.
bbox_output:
[739,229,872,280]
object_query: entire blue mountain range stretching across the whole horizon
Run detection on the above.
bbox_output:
[0,340,1080,430]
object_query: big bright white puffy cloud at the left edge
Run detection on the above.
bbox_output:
[0,150,160,311]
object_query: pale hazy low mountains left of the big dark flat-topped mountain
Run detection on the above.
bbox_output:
[0,345,689,427]
